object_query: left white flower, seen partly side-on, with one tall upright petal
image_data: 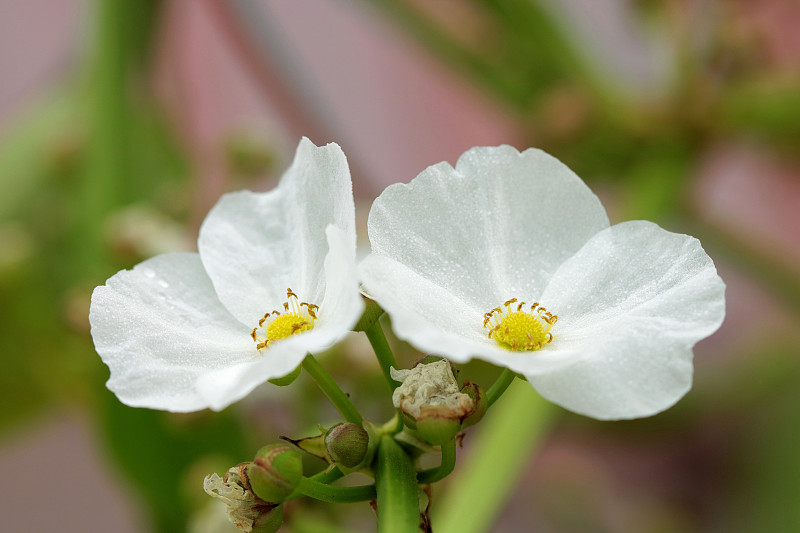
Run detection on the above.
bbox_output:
[89,139,363,412]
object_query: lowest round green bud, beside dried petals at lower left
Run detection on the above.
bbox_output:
[245,444,303,503]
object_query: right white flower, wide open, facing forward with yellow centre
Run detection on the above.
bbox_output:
[360,146,725,419]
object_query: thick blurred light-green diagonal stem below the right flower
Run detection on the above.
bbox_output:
[433,380,553,533]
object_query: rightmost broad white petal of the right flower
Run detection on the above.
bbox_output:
[516,221,725,419]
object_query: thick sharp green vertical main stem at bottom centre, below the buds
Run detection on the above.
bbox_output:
[375,435,419,533]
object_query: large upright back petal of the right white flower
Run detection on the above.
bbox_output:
[364,146,608,314]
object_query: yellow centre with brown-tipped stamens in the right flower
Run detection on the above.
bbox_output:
[483,298,558,351]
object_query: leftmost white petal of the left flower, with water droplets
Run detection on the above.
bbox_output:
[89,253,258,412]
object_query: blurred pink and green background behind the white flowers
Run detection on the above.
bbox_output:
[0,0,800,533]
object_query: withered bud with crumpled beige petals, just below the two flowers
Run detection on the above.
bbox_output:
[391,359,474,445]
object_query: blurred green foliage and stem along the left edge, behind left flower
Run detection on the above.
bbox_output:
[0,1,247,532]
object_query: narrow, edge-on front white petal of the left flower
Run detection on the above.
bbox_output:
[199,225,364,409]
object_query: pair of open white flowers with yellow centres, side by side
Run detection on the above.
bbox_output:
[90,139,725,419]
